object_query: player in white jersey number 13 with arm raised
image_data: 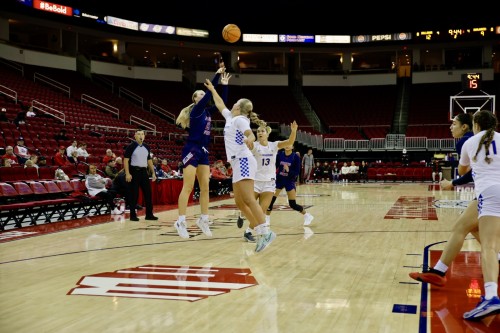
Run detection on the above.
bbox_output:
[234,121,298,242]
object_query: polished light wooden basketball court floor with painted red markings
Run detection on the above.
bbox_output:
[0,183,500,333]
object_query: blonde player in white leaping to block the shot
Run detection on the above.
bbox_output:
[205,73,276,252]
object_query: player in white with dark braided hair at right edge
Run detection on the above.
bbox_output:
[458,110,500,320]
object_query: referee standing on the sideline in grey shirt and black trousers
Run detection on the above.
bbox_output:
[123,130,158,221]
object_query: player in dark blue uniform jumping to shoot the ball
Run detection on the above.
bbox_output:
[174,62,227,238]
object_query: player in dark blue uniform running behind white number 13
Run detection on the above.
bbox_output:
[266,145,314,226]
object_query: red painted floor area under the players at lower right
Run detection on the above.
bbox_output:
[427,251,500,333]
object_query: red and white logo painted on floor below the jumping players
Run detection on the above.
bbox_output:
[68,265,258,302]
